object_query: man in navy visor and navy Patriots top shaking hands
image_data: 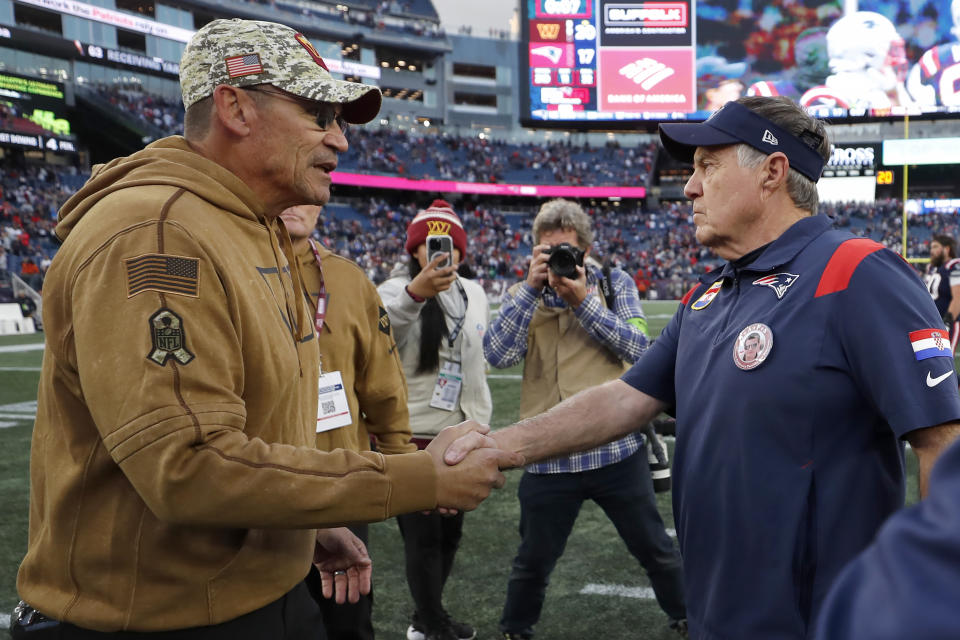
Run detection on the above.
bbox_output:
[446,97,960,640]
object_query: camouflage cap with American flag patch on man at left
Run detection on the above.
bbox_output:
[180,18,381,124]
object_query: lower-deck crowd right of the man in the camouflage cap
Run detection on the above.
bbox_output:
[318,198,948,299]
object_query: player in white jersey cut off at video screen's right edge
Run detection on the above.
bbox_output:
[907,0,960,107]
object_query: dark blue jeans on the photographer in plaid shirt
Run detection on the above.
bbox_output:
[500,449,687,635]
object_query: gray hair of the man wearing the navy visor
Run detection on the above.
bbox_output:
[737,96,830,215]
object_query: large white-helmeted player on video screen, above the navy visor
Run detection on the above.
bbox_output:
[800,11,913,109]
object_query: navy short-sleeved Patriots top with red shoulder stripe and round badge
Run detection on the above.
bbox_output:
[623,216,960,640]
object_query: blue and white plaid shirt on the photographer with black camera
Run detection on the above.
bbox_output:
[483,265,649,473]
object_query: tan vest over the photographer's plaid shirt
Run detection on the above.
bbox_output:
[509,283,630,418]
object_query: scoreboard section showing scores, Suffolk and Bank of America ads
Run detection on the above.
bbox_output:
[524,0,696,120]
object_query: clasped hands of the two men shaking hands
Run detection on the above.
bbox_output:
[426,420,524,513]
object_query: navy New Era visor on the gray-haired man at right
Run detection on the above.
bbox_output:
[660,102,824,182]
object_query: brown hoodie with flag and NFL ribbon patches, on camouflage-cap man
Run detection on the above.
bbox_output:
[17,137,436,631]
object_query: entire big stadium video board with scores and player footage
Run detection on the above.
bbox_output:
[520,0,960,127]
